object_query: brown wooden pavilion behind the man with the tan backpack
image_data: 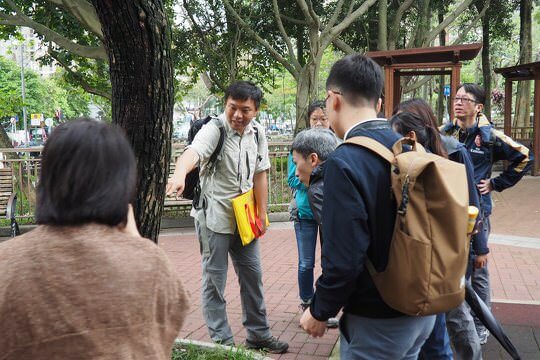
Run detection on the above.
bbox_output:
[366,43,482,119]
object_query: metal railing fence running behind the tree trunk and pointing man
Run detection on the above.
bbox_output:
[0,141,292,221]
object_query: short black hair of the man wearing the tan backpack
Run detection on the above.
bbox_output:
[326,54,384,107]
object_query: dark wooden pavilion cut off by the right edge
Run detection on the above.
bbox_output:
[495,61,540,176]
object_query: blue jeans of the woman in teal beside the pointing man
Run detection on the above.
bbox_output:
[294,219,319,303]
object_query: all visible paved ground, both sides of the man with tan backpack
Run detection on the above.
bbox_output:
[160,177,540,359]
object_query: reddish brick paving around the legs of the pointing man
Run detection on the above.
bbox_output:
[160,224,338,359]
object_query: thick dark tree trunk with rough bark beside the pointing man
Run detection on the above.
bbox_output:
[92,0,174,242]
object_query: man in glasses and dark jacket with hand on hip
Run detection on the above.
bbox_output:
[441,83,533,345]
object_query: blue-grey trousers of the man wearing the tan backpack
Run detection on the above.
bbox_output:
[339,313,435,360]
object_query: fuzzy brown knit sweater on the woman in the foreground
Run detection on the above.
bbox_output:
[0,224,188,360]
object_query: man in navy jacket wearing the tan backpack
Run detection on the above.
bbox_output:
[300,55,435,359]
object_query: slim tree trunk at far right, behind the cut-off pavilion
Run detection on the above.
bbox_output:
[514,0,532,127]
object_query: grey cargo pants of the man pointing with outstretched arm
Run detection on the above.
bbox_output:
[195,212,272,344]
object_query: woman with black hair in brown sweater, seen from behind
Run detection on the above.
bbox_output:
[0,119,187,359]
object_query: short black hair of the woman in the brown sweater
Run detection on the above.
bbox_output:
[36,118,137,226]
